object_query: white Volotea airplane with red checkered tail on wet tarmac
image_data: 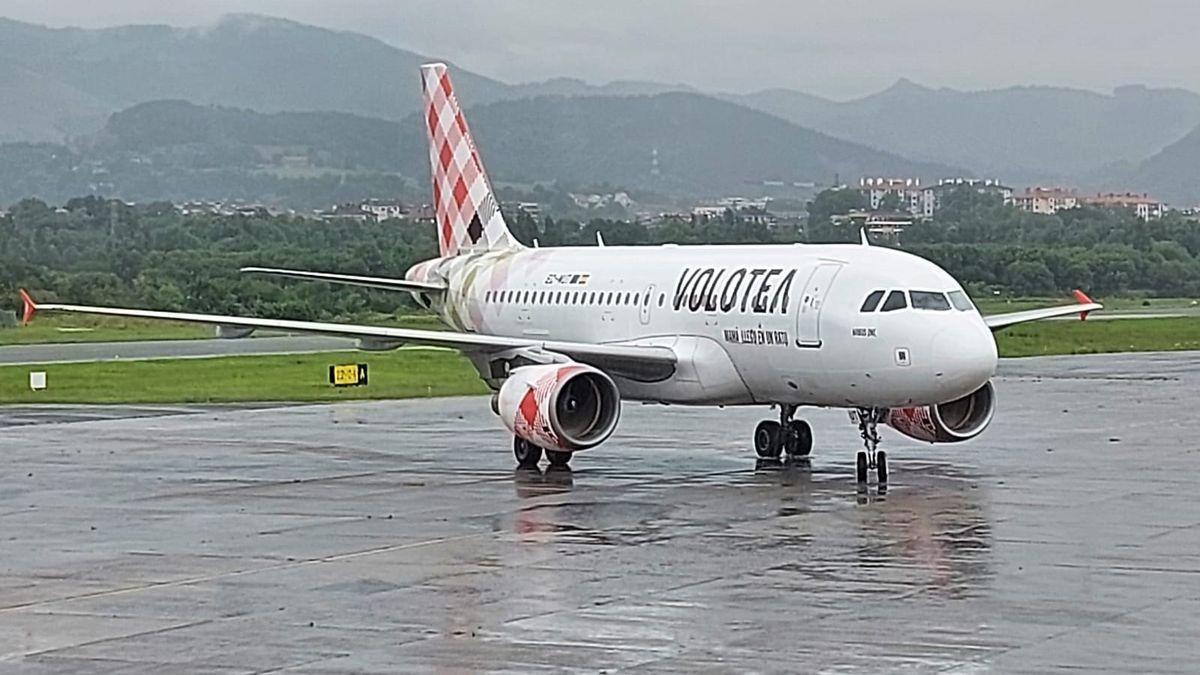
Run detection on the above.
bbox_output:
[20,64,1100,485]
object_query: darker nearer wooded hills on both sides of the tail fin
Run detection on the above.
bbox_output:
[0,92,954,208]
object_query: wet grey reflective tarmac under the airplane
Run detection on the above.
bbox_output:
[0,353,1200,673]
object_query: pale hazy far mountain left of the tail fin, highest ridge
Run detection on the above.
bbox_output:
[0,14,508,141]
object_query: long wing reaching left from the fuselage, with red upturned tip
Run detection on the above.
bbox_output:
[20,291,677,381]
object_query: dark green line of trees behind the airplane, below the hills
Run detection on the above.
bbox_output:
[0,190,1200,319]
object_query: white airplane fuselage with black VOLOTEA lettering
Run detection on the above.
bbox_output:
[410,245,996,407]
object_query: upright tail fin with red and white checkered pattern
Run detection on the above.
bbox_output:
[421,64,520,256]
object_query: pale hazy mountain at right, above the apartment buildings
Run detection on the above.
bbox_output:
[726,79,1200,183]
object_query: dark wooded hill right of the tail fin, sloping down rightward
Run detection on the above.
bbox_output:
[401,92,954,193]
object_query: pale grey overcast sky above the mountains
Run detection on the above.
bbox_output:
[9,0,1200,98]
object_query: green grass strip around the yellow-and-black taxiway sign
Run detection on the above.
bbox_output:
[0,348,487,404]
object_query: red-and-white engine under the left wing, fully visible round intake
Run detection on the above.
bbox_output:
[497,363,620,452]
